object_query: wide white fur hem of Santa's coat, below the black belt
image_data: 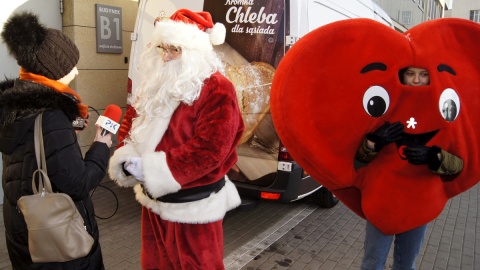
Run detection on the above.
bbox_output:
[134,176,241,224]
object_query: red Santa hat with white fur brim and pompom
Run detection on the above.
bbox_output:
[152,9,226,51]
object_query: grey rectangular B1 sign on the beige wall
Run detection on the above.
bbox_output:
[95,4,123,53]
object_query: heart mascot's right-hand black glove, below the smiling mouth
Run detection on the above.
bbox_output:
[403,145,442,171]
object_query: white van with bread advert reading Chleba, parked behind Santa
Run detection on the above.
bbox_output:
[127,0,392,207]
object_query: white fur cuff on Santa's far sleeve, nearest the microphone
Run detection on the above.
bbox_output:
[108,144,139,187]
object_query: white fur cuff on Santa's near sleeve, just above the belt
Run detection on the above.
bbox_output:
[142,151,182,197]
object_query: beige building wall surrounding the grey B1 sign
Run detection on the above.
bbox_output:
[63,0,138,152]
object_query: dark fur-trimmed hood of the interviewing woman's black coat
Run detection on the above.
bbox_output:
[0,79,80,153]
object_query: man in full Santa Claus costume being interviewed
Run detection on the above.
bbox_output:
[109,10,243,269]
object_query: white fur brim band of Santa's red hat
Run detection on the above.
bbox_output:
[152,20,213,51]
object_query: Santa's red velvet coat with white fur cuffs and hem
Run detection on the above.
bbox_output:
[109,72,243,223]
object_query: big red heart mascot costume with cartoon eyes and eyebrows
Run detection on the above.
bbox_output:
[271,18,480,234]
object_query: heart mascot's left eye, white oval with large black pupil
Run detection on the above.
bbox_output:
[363,85,390,117]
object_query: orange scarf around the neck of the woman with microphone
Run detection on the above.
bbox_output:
[20,67,88,118]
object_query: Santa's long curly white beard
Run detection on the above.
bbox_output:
[127,46,223,143]
